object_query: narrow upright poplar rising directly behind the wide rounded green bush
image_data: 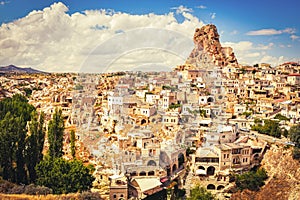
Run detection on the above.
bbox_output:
[48,108,65,158]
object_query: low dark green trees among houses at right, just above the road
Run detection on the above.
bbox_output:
[252,120,282,138]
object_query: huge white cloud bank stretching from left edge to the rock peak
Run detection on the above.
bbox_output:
[0,3,203,72]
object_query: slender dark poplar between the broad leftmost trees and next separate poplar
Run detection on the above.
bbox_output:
[25,112,45,183]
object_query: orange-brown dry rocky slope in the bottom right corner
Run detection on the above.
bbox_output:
[231,145,300,200]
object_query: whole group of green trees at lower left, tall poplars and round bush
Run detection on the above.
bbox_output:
[0,95,94,194]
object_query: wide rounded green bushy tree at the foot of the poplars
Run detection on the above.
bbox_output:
[36,157,94,194]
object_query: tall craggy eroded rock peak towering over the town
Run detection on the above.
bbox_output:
[186,24,238,67]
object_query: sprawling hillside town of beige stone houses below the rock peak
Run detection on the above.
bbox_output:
[0,62,300,200]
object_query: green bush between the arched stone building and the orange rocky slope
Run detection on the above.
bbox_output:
[235,169,268,191]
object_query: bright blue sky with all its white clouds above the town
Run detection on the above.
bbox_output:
[0,0,300,72]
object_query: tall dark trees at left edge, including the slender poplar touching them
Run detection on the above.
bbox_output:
[0,95,45,184]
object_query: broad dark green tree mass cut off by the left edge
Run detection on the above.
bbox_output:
[0,94,35,183]
